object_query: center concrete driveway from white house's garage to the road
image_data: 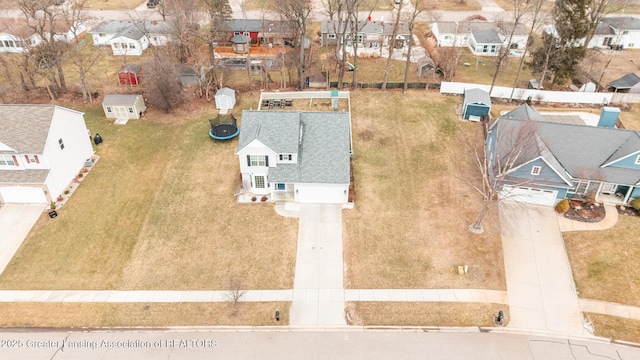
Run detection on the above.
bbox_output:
[289,204,346,325]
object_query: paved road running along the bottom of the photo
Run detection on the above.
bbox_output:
[0,328,640,360]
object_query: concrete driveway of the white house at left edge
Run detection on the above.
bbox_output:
[0,204,47,274]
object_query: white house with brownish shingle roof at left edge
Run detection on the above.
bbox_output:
[0,105,93,204]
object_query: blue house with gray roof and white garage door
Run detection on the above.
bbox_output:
[486,104,640,205]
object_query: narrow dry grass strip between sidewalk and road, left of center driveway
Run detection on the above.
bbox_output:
[0,302,290,328]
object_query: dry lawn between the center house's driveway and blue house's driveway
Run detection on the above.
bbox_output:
[343,90,505,290]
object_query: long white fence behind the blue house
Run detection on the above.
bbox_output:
[440,82,640,105]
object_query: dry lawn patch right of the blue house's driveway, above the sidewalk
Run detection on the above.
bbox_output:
[563,215,640,306]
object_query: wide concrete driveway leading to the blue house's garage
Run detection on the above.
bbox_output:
[500,201,588,335]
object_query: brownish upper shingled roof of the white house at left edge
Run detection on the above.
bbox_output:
[0,105,56,154]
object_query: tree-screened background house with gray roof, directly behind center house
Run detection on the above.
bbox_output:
[320,20,410,54]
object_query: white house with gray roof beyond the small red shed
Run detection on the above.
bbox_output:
[89,20,173,56]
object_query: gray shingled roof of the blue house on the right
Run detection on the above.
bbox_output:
[496,105,640,185]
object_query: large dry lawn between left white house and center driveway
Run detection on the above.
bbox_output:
[0,98,297,290]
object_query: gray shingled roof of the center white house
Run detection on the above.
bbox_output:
[236,110,351,184]
